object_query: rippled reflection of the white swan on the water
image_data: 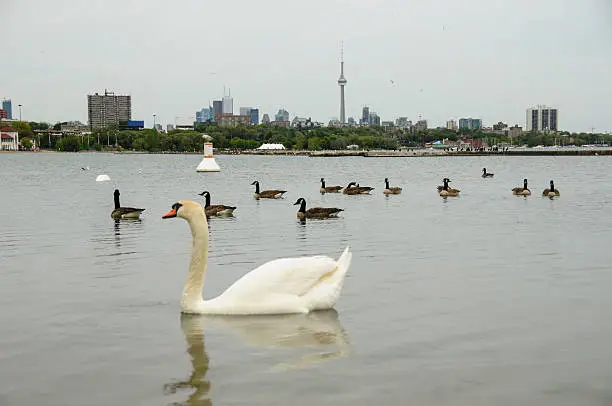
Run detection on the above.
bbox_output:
[164,309,350,406]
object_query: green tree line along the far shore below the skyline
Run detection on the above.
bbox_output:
[5,122,612,156]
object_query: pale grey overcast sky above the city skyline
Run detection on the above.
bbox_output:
[0,0,612,131]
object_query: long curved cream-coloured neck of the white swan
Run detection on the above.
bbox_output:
[181,210,208,308]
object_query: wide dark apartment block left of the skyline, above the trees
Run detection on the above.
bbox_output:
[87,90,132,130]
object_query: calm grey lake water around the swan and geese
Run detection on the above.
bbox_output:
[0,153,612,406]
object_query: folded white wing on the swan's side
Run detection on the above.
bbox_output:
[222,256,338,300]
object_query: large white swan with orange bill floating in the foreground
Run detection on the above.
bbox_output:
[162,200,352,315]
